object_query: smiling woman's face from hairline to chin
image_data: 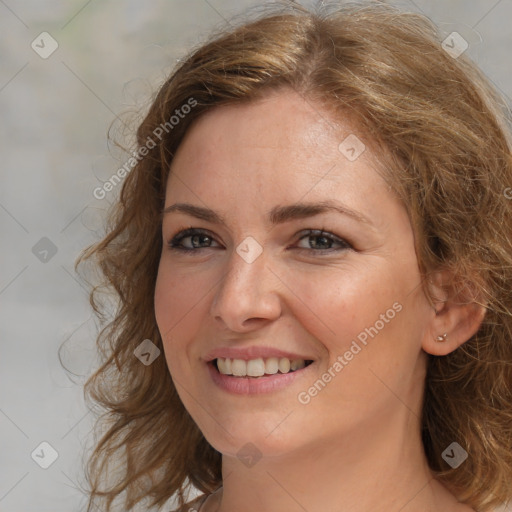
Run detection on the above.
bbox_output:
[155,90,434,456]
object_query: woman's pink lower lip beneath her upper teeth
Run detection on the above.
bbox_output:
[207,362,315,395]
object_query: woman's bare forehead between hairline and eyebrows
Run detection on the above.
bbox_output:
[166,91,404,234]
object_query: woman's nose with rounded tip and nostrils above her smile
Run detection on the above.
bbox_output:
[210,244,281,332]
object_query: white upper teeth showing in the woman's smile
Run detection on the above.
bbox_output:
[217,357,306,377]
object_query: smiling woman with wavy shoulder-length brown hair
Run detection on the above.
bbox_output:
[77,3,512,512]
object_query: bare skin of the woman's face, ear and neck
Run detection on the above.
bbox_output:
[155,89,483,512]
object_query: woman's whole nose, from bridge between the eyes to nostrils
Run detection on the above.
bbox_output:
[211,241,280,330]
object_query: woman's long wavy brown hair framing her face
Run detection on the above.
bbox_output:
[76,3,512,512]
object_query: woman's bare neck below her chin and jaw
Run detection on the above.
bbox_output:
[211,403,456,512]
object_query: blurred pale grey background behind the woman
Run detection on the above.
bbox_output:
[0,0,512,512]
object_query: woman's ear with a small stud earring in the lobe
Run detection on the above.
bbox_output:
[422,270,487,356]
